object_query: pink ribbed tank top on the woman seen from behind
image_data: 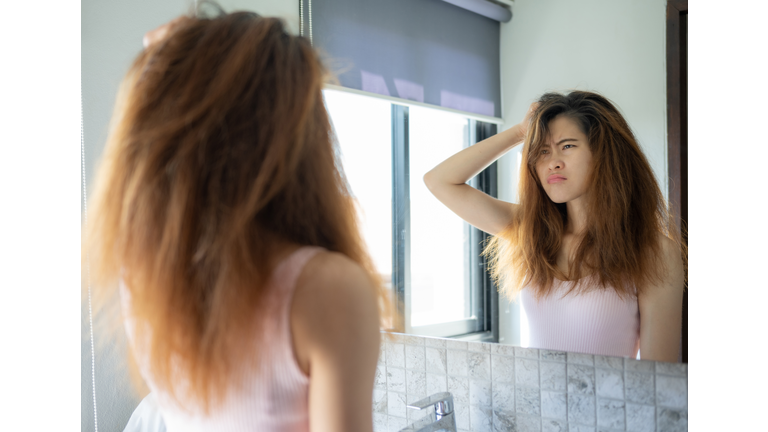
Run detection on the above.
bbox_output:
[121,247,323,432]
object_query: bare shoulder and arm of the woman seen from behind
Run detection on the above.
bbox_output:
[291,252,381,432]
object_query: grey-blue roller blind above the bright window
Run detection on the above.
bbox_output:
[300,0,501,117]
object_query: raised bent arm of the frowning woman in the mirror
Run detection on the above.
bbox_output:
[424,103,536,235]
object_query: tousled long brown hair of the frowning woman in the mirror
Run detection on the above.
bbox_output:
[484,91,686,298]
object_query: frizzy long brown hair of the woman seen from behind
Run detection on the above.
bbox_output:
[83,6,391,411]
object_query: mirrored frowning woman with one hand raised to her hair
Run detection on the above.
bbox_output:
[424,91,684,361]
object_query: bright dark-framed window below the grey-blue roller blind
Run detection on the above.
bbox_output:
[323,89,498,340]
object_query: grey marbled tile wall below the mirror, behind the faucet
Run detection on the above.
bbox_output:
[373,334,688,432]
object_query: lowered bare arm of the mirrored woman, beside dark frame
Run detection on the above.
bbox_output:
[637,237,685,362]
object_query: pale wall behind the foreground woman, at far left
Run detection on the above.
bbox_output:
[80,0,299,431]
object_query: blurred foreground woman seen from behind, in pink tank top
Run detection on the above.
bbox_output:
[86,7,386,431]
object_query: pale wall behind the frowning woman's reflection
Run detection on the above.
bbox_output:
[499,0,667,344]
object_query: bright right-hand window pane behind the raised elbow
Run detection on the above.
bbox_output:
[409,107,473,327]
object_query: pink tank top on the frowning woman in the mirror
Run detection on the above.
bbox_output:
[520,279,640,358]
